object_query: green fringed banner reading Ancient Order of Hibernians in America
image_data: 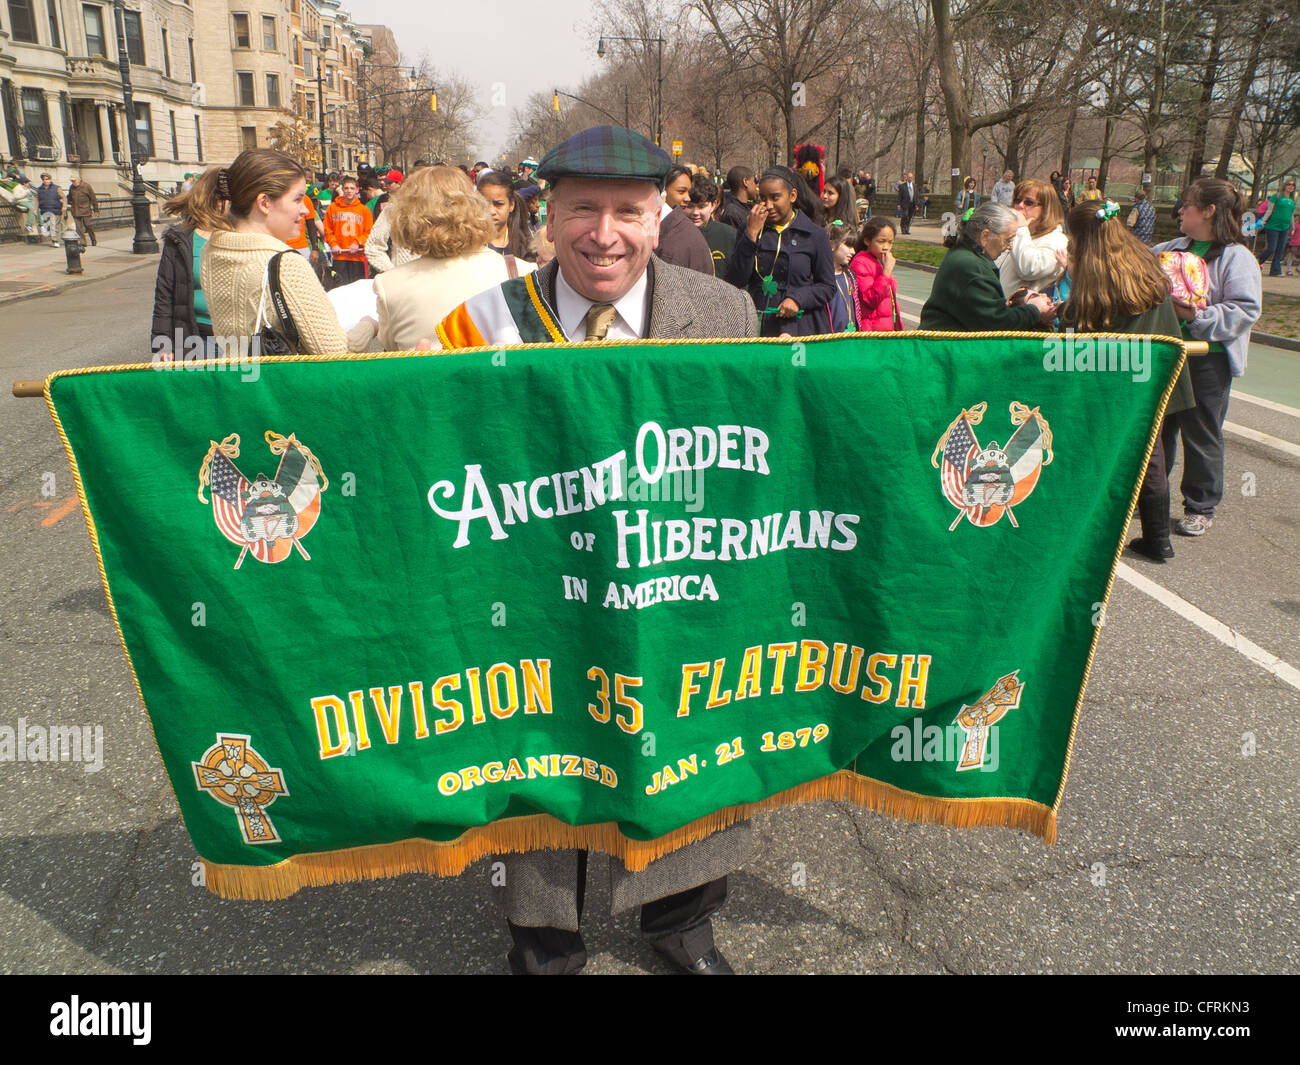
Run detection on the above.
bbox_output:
[47,334,1183,897]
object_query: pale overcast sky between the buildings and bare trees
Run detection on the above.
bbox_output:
[343,0,611,163]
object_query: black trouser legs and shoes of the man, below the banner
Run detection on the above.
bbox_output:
[506,850,727,975]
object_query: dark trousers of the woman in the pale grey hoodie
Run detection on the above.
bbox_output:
[1161,352,1232,518]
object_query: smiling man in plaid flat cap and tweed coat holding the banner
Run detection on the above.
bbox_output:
[438,126,758,975]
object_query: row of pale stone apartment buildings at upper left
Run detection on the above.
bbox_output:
[0,0,363,195]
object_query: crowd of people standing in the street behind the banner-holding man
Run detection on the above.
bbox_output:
[147,143,1263,560]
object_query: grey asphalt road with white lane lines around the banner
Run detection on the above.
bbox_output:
[0,269,1300,974]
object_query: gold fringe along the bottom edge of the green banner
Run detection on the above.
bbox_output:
[202,770,1057,901]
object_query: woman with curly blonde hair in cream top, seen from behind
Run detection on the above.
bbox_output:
[374,166,536,351]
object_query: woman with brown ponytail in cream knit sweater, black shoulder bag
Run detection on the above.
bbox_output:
[199,148,376,355]
